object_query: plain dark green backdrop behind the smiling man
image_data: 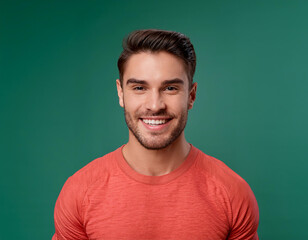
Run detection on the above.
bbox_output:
[0,0,308,240]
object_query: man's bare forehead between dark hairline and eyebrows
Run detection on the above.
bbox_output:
[123,52,188,84]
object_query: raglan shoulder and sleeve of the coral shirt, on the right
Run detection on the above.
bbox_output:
[196,146,259,239]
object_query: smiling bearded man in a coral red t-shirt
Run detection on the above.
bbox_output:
[53,30,259,240]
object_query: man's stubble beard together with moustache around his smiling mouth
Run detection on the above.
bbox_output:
[124,106,188,150]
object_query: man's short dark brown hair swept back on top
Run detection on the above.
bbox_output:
[118,29,196,88]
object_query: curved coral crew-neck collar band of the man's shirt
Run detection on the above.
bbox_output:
[115,144,198,185]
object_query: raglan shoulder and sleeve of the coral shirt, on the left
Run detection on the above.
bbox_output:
[54,148,121,234]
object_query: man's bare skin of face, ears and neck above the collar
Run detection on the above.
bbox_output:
[117,52,197,175]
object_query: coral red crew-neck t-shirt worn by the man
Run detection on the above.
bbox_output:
[52,146,259,240]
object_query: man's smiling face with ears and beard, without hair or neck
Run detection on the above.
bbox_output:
[117,52,196,150]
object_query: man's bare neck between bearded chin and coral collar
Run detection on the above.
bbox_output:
[123,132,190,176]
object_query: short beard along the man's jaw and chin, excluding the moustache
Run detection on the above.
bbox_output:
[124,106,188,150]
